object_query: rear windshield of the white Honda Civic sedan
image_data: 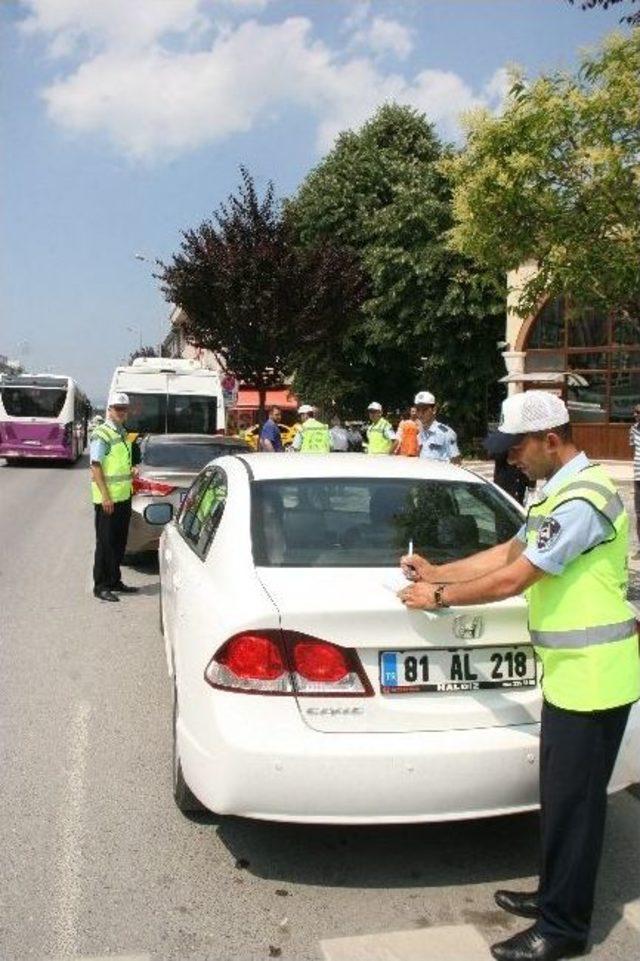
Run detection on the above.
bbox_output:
[251,478,522,567]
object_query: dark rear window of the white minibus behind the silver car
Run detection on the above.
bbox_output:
[127,391,218,434]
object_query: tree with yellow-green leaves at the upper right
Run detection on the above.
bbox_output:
[443,30,640,313]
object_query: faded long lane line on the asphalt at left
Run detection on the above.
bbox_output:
[53,701,91,956]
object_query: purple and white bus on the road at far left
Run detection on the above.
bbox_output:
[0,374,91,463]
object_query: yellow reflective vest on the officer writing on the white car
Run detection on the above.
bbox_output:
[526,464,640,711]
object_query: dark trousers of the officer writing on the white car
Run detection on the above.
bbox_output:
[538,701,631,940]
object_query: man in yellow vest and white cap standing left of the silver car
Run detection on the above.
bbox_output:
[90,393,138,601]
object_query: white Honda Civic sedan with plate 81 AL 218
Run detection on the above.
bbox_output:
[148,454,640,824]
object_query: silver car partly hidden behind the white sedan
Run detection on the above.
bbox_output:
[127,434,251,554]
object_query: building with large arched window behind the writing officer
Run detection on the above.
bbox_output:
[502,264,640,460]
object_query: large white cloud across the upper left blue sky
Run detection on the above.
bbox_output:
[20,0,503,163]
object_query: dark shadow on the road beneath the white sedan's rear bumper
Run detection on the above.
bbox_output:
[217,814,538,888]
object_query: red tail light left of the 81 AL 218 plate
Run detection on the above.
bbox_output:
[204,630,373,697]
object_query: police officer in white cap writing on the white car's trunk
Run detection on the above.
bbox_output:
[399,390,640,961]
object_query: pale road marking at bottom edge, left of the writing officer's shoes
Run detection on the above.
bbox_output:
[320,924,491,961]
